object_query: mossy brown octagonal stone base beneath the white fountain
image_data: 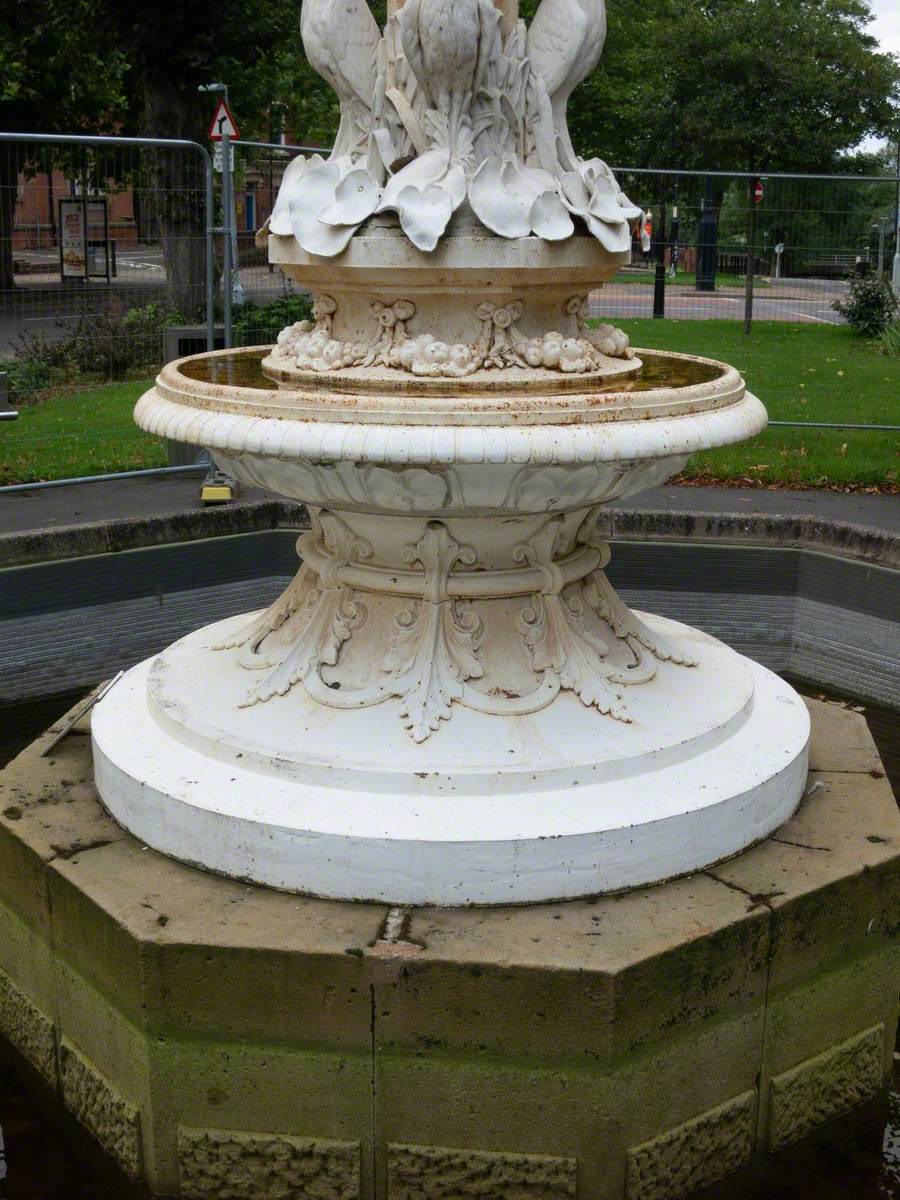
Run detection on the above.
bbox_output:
[0,703,900,1200]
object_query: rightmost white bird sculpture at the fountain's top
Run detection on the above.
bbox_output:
[526,0,606,170]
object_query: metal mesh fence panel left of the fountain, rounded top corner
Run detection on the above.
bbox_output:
[0,133,215,479]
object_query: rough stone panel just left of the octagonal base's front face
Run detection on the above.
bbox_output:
[60,1038,142,1178]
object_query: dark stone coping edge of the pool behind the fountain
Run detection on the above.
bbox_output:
[0,498,900,569]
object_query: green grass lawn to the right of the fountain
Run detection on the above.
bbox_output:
[620,320,900,490]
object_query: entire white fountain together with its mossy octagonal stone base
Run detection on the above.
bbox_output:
[0,0,900,1200]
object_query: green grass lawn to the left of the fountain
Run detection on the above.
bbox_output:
[0,379,166,484]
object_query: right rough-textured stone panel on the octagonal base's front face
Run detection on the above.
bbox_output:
[388,1146,577,1200]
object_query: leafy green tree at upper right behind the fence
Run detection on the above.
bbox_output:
[571,0,900,172]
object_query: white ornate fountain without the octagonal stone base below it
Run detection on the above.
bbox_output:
[94,0,809,905]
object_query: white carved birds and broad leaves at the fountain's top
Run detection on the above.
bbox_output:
[268,0,640,256]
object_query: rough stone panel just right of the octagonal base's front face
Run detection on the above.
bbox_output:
[628,1092,756,1200]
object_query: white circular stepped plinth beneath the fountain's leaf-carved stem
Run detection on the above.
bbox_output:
[92,617,809,905]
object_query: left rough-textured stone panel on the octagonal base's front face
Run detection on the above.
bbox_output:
[178,1128,360,1200]
